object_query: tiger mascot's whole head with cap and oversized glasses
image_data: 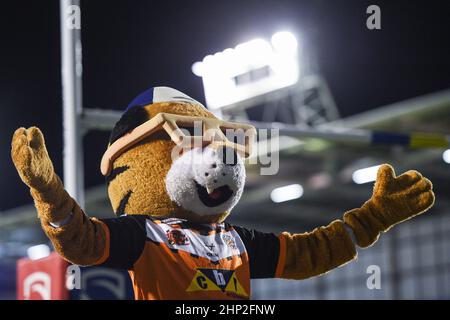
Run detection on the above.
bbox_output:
[101,87,255,223]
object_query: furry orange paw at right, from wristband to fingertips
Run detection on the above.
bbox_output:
[344,164,434,248]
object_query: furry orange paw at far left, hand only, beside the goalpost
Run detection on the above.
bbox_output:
[11,127,55,191]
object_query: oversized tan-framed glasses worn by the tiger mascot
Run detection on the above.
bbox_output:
[100,112,256,176]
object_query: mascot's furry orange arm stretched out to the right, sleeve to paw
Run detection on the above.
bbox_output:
[276,165,434,279]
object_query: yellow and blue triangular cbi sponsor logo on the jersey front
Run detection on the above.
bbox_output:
[186,268,248,298]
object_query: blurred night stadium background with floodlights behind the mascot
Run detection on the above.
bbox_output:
[0,0,450,299]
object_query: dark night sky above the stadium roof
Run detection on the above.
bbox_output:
[0,0,450,210]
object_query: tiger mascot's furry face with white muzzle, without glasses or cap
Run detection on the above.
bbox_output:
[106,90,245,223]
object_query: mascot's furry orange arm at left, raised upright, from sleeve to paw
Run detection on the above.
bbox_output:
[11,127,109,265]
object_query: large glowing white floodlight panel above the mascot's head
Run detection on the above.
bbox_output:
[192,31,300,109]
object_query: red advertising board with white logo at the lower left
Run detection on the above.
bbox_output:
[17,252,69,300]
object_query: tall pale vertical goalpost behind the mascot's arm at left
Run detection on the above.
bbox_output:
[60,0,84,208]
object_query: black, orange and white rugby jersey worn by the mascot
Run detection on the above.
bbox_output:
[98,215,284,300]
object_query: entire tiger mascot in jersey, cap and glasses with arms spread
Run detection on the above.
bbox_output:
[11,87,434,299]
